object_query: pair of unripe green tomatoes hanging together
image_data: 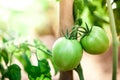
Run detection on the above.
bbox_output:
[52,26,109,71]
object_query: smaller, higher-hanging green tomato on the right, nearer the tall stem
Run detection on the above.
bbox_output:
[80,26,109,54]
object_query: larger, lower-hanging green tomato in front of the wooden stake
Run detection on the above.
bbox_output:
[52,37,83,71]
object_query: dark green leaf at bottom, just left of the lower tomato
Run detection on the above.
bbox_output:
[28,59,51,80]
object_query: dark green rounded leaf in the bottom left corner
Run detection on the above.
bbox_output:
[4,64,21,80]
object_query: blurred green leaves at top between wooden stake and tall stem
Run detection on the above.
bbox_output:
[73,0,109,26]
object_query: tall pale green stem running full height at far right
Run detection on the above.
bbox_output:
[106,0,118,80]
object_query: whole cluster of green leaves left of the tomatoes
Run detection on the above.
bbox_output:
[0,38,51,80]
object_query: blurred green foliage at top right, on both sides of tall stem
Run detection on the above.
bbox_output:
[73,0,120,35]
